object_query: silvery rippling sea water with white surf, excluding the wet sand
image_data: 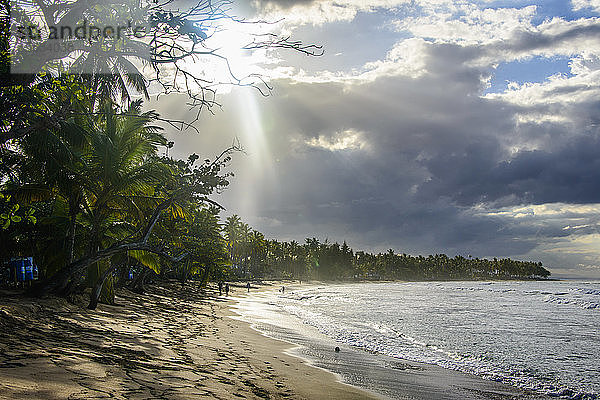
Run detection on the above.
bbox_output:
[274,282,600,399]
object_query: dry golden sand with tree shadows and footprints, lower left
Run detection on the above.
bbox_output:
[0,283,373,399]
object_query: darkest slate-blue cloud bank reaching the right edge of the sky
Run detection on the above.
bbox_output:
[420,132,600,205]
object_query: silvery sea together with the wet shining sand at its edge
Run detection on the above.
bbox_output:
[235,280,600,399]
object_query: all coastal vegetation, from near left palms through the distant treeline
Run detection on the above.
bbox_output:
[0,1,549,308]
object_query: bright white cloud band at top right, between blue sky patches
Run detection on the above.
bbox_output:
[395,12,600,66]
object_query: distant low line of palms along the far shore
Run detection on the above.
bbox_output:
[224,216,550,280]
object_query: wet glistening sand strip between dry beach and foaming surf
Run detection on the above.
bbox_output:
[236,282,551,400]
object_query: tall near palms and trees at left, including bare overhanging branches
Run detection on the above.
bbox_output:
[0,0,320,305]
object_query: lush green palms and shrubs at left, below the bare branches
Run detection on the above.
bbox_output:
[2,81,234,302]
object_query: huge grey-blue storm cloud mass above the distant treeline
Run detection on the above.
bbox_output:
[151,23,600,276]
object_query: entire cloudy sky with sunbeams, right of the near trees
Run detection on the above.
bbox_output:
[150,0,600,278]
